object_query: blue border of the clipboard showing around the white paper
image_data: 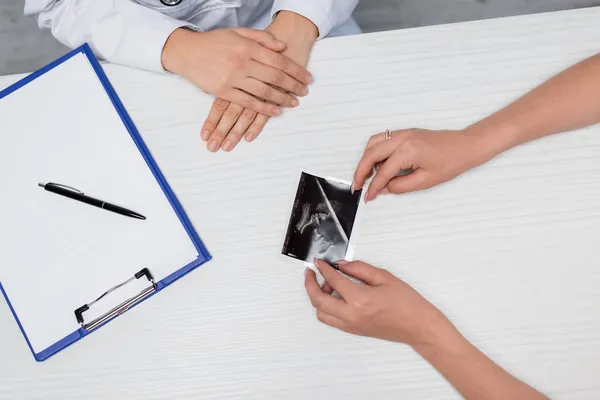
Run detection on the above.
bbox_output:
[0,44,211,361]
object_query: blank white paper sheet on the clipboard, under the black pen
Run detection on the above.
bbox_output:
[0,54,198,353]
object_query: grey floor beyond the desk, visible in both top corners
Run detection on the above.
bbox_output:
[0,0,600,75]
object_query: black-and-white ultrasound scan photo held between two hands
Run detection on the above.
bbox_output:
[282,172,362,264]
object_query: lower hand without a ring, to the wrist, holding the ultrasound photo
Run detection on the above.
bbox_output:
[305,260,459,347]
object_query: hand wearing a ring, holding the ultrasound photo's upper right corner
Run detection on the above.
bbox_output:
[352,129,495,201]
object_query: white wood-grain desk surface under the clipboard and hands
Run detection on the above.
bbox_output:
[0,8,600,399]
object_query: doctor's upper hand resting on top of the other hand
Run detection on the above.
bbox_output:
[162,28,312,116]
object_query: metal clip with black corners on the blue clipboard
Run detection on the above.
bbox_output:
[75,268,156,331]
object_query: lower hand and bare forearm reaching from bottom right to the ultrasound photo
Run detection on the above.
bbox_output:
[305,260,547,400]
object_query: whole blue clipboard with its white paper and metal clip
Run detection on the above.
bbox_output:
[0,44,211,361]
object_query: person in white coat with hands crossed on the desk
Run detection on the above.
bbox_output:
[25,0,360,151]
